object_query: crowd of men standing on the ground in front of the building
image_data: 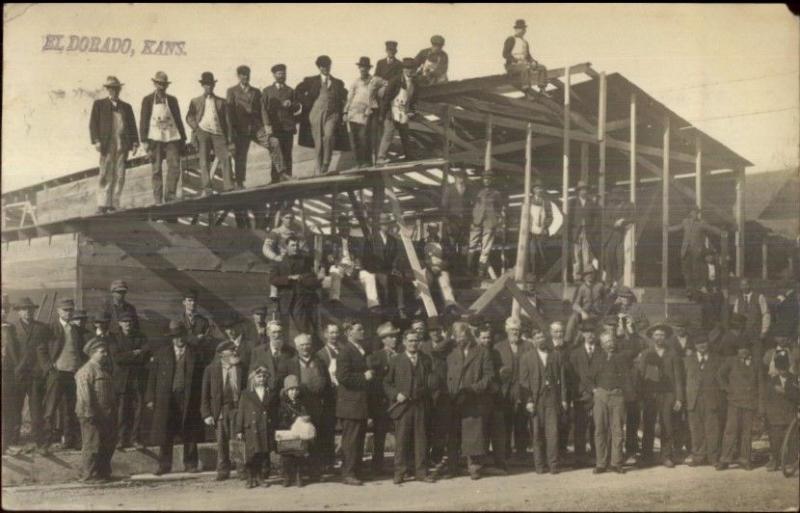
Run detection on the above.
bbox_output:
[2,268,800,485]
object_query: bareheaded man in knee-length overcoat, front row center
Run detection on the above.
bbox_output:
[447,321,494,480]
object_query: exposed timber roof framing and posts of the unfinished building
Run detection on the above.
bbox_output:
[2,63,752,317]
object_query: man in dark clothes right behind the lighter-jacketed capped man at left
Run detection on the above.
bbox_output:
[107,312,152,449]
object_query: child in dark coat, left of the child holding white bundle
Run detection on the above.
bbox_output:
[236,366,272,488]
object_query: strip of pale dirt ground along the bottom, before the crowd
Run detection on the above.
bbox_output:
[2,465,800,511]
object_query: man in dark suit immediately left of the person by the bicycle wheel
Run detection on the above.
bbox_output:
[716,338,761,470]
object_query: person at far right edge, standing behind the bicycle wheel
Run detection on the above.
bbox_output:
[759,351,800,472]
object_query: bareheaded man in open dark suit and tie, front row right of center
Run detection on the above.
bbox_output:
[519,329,567,474]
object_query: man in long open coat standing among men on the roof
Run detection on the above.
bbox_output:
[297,55,347,175]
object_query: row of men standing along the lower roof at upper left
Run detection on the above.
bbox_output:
[89,35,456,213]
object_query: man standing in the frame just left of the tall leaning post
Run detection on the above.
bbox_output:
[467,170,504,277]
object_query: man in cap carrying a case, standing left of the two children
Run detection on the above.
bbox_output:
[200,340,247,481]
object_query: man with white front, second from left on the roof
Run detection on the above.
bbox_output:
[139,71,186,205]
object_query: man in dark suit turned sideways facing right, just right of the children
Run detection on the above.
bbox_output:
[336,321,375,486]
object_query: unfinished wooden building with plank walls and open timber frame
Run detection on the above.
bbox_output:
[2,63,752,336]
